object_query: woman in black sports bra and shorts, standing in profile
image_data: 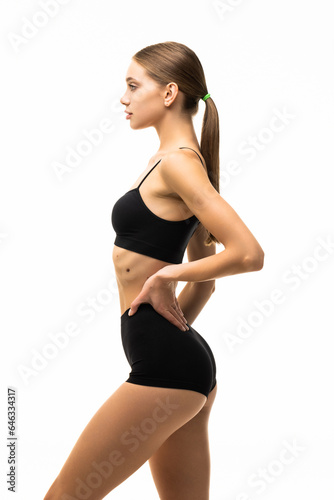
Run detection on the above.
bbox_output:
[45,42,264,500]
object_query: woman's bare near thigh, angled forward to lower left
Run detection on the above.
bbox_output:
[44,382,207,500]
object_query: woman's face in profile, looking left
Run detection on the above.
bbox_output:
[120,60,166,129]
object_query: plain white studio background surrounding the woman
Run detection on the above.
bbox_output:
[0,0,334,500]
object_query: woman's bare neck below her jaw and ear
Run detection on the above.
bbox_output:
[154,110,200,153]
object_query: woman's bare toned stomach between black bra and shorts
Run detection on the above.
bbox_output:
[112,245,171,315]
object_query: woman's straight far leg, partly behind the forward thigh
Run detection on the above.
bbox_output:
[149,384,217,500]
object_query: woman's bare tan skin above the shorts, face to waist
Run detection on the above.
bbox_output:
[113,61,264,330]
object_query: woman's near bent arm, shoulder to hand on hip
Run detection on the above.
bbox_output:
[131,151,264,326]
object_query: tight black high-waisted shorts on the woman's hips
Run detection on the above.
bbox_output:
[121,303,216,397]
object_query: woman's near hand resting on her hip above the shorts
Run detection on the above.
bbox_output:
[129,274,189,331]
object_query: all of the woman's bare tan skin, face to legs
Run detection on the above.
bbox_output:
[44,57,263,500]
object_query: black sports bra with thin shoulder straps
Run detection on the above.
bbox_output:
[111,147,203,264]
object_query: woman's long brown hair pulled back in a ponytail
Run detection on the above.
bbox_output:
[132,42,220,246]
